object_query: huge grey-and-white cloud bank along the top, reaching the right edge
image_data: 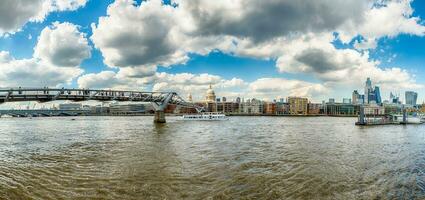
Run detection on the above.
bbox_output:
[91,0,425,67]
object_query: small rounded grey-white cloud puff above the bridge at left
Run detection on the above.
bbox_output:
[34,22,91,67]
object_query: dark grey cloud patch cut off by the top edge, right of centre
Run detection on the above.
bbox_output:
[176,0,368,41]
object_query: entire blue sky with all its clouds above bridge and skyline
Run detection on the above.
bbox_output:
[0,0,425,103]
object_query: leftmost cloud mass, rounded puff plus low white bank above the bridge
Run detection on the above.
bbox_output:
[0,23,90,87]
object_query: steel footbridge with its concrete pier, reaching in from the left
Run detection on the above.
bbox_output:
[0,87,203,123]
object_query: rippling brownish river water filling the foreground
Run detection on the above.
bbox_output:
[0,117,425,199]
